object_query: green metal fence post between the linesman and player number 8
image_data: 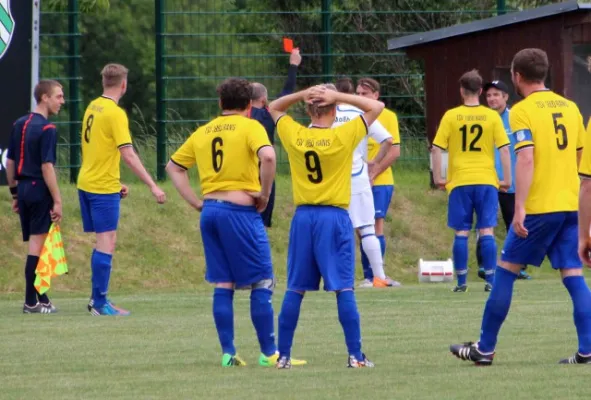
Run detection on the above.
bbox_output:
[68,0,81,183]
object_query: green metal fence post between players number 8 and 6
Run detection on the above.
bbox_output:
[155,0,166,180]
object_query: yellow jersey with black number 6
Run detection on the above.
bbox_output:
[170,114,271,195]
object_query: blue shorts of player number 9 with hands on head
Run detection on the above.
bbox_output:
[287,206,355,291]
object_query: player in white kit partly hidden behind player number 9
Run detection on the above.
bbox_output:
[333,104,394,287]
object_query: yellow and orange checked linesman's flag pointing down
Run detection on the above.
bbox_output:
[35,224,68,294]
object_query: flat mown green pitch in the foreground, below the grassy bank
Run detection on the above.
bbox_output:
[0,280,590,400]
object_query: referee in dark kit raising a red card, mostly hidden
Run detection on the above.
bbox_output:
[249,49,302,228]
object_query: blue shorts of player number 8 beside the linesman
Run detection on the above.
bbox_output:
[78,189,121,233]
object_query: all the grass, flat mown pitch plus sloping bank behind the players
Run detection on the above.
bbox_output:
[0,169,591,400]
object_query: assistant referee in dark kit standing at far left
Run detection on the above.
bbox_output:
[6,80,65,314]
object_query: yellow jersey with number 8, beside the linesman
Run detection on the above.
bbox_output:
[78,96,132,194]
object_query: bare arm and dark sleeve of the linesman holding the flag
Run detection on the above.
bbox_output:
[41,125,62,222]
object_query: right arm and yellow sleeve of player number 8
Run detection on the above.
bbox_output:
[112,110,166,204]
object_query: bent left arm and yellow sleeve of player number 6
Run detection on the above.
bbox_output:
[166,136,203,211]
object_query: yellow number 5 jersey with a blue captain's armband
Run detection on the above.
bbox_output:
[509,90,585,214]
